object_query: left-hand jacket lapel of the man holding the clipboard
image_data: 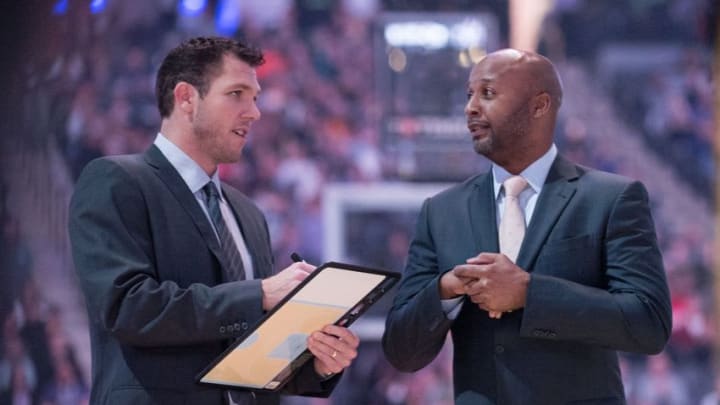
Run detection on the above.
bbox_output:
[144,145,228,268]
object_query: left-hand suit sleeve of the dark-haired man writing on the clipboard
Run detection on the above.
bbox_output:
[69,159,262,347]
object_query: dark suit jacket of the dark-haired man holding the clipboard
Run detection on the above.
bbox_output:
[69,146,332,405]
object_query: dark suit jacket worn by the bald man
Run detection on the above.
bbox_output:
[383,157,671,405]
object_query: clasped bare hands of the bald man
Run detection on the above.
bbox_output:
[440,253,530,319]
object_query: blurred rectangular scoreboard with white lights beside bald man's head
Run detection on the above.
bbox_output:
[373,13,499,181]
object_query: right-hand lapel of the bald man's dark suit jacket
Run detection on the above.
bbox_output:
[517,155,578,269]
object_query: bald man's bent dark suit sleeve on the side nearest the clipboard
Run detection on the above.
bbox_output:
[382,200,452,371]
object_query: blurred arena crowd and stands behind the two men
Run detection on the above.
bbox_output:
[0,0,720,405]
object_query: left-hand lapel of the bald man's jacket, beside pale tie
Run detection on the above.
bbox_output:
[468,172,500,253]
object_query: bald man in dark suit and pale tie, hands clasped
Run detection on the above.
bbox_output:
[383,49,672,405]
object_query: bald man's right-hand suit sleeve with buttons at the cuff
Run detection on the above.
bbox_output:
[520,182,672,354]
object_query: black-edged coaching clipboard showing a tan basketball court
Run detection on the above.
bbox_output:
[197,262,400,391]
